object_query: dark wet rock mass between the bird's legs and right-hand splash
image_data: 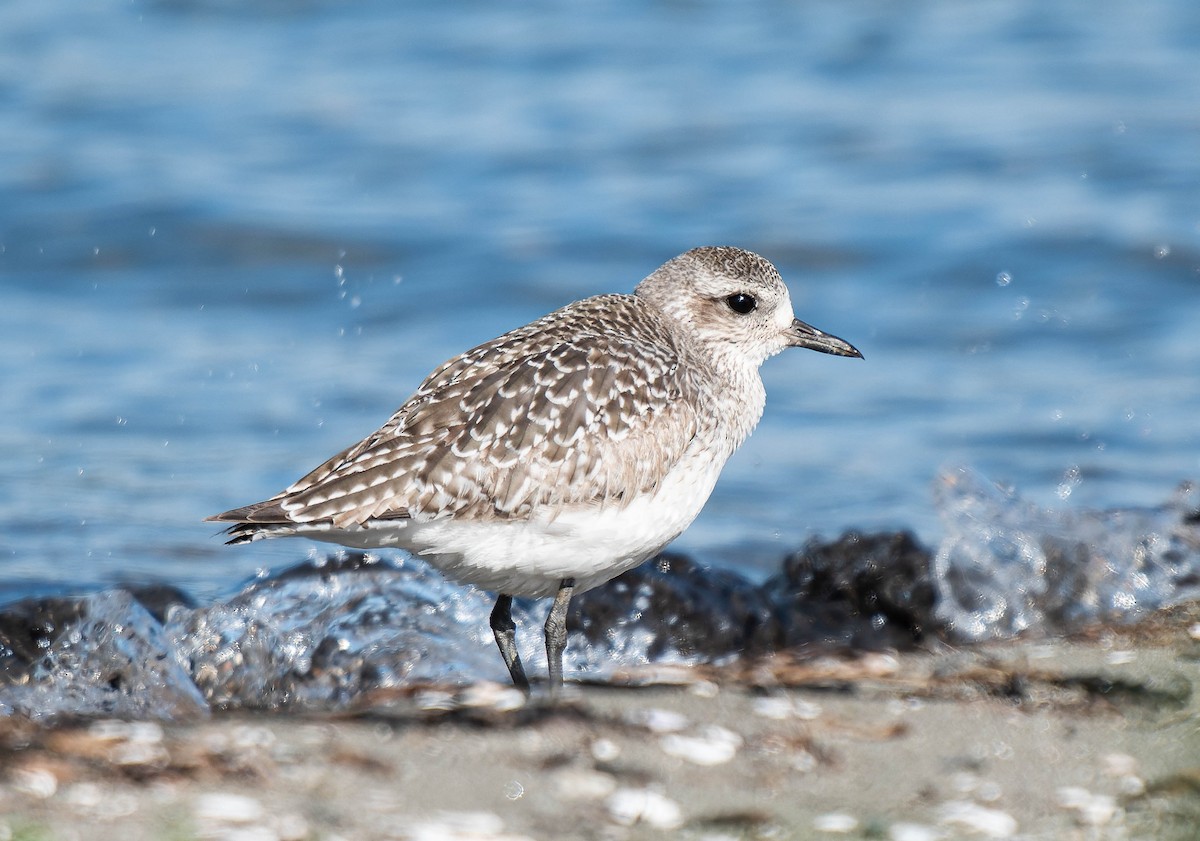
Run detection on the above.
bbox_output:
[570,531,942,660]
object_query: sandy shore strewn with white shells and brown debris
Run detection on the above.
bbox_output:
[0,606,1200,841]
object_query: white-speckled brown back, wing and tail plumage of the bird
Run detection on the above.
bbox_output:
[221,295,720,530]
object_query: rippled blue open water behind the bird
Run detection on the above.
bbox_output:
[0,0,1200,599]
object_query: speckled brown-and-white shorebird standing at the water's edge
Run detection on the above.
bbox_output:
[206,246,863,697]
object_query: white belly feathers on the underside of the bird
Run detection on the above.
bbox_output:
[309,453,725,597]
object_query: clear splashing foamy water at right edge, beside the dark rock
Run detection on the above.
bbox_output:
[935,468,1200,641]
